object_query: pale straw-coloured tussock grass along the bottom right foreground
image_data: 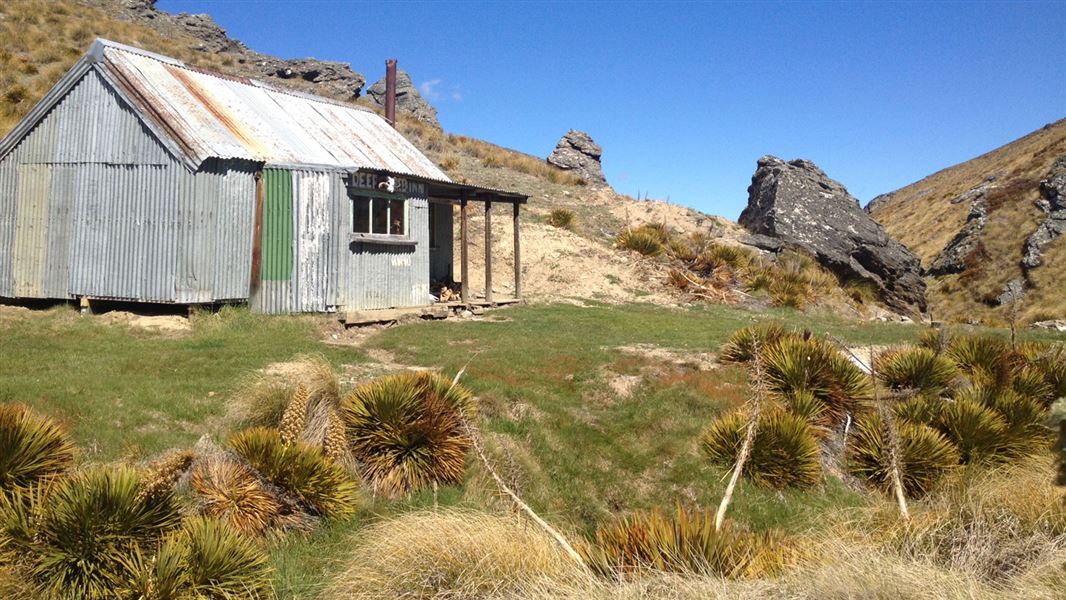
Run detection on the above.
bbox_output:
[323,458,1066,600]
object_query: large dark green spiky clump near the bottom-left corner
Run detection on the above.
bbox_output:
[31,467,180,598]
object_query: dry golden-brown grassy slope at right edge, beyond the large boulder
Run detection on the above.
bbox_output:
[873,119,1066,321]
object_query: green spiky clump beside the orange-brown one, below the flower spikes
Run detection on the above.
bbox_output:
[229,427,357,519]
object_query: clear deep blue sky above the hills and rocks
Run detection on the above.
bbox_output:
[159,0,1066,218]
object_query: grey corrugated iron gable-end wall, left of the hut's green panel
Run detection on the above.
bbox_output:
[0,71,255,304]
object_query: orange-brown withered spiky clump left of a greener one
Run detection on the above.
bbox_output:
[190,458,282,535]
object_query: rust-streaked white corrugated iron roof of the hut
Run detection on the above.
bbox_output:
[90,39,450,181]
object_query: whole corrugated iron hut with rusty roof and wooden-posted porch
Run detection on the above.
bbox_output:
[0,40,527,321]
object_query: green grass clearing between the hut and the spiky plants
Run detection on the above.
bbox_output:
[0,304,1062,598]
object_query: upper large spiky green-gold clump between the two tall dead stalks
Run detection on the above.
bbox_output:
[763,337,870,426]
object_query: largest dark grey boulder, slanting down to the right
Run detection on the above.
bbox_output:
[739,157,925,313]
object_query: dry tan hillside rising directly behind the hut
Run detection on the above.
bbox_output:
[0,0,884,314]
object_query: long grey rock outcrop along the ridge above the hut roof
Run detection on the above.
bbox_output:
[101,0,367,100]
